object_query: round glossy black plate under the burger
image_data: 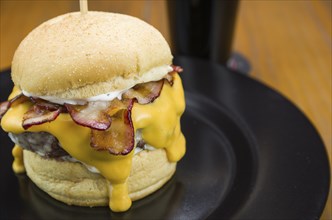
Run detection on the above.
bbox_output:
[0,58,330,219]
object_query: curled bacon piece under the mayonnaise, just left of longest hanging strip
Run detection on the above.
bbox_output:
[65,102,112,130]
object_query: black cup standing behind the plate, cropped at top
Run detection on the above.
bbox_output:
[167,0,238,64]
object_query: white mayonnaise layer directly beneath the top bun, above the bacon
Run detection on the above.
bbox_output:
[22,65,173,105]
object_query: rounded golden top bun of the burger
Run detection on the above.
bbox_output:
[12,11,173,99]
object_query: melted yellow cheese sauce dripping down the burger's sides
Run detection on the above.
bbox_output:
[1,74,185,211]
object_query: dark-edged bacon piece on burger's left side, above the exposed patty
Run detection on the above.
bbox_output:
[22,105,61,129]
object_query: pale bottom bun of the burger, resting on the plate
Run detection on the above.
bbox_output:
[24,149,176,206]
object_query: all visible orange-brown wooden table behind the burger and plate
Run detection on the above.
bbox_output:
[0,0,332,219]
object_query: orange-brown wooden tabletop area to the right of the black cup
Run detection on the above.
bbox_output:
[234,1,332,220]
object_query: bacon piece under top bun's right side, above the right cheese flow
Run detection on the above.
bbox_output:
[122,79,164,104]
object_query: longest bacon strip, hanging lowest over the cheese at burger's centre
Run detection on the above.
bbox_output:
[90,99,135,155]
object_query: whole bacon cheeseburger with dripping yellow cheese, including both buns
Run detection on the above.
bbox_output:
[0,11,185,212]
